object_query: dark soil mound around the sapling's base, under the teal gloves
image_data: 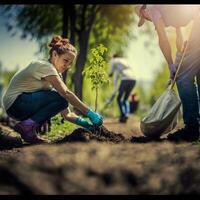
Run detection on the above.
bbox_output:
[53,126,126,144]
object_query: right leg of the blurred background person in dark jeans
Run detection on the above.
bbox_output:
[122,80,136,117]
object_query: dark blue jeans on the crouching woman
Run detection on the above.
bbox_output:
[7,90,68,124]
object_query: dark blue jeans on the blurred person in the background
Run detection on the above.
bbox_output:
[117,80,136,118]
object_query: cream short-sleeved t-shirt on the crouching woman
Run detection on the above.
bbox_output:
[2,60,59,110]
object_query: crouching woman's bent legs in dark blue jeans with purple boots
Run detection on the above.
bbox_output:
[8,91,68,143]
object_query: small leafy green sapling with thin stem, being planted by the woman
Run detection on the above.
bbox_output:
[83,44,110,112]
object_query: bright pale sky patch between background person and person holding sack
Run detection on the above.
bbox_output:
[127,22,165,82]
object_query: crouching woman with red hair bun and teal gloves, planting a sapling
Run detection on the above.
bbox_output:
[3,36,103,143]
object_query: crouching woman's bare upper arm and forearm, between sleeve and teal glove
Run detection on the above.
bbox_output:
[45,76,89,114]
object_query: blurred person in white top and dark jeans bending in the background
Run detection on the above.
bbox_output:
[109,54,136,123]
